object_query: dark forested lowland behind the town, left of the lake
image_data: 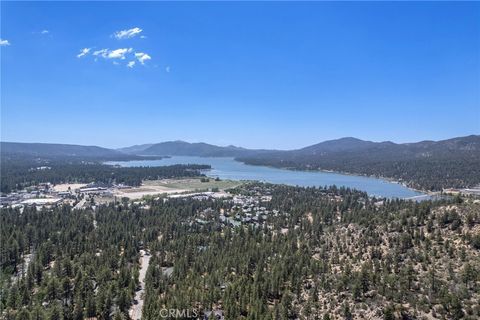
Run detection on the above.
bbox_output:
[0,157,210,193]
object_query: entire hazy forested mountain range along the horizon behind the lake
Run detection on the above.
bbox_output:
[1,135,480,190]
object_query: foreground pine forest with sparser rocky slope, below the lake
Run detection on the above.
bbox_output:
[0,184,480,320]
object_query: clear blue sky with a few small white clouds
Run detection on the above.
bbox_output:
[0,1,480,149]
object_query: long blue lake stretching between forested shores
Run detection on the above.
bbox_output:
[106,156,422,198]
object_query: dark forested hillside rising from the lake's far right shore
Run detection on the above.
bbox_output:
[237,136,480,191]
